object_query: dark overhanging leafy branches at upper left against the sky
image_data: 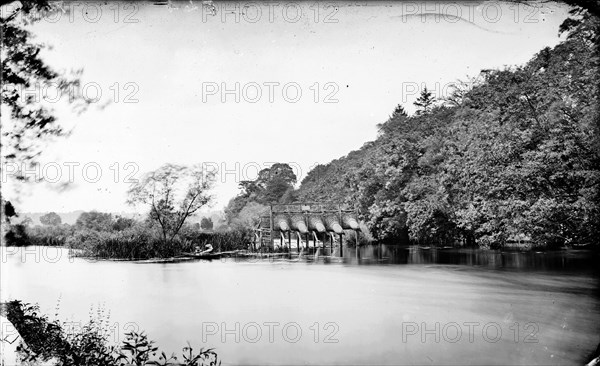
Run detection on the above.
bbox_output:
[0,0,90,166]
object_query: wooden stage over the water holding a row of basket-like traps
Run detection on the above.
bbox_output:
[254,202,360,257]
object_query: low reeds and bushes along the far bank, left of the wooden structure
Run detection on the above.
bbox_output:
[4,209,253,259]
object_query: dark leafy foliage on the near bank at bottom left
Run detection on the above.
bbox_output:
[6,300,221,366]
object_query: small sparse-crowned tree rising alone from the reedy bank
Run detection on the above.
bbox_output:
[128,164,215,243]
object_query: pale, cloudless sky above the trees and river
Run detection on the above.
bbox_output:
[2,1,568,212]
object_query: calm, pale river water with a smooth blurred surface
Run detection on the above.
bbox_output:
[0,246,600,365]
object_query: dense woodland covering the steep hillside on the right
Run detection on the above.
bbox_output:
[228,8,600,247]
